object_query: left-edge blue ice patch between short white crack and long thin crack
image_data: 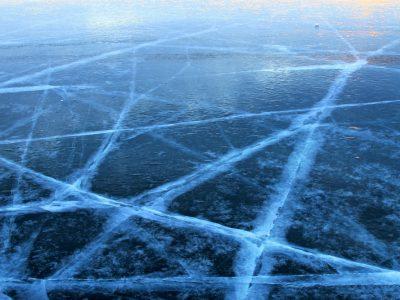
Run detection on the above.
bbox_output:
[0,86,122,142]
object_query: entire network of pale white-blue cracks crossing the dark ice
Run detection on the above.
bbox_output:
[0,17,400,299]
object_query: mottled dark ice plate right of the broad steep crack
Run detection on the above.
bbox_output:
[274,127,400,269]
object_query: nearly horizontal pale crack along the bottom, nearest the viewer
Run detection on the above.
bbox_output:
[0,272,400,293]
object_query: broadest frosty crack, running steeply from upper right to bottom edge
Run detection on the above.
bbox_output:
[230,34,397,299]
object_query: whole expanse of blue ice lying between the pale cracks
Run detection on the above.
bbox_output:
[0,3,398,298]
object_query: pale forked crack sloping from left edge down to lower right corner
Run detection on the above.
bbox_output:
[0,157,390,272]
